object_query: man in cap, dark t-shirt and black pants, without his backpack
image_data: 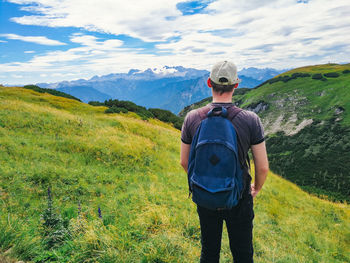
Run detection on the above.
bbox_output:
[181,61,269,263]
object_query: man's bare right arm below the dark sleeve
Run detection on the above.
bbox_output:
[251,141,269,197]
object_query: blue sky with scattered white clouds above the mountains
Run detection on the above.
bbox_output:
[0,0,350,85]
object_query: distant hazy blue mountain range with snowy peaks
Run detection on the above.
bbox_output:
[36,66,284,114]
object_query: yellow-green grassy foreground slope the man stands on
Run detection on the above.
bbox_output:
[0,87,350,263]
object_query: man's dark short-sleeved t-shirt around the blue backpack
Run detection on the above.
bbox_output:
[181,103,265,196]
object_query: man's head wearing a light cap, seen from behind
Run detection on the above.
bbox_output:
[208,61,241,95]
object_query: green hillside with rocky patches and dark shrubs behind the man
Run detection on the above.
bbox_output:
[181,64,350,202]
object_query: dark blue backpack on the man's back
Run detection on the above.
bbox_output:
[188,107,244,210]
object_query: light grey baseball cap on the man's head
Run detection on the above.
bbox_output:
[210,60,241,85]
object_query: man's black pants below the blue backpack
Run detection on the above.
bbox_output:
[197,194,254,263]
